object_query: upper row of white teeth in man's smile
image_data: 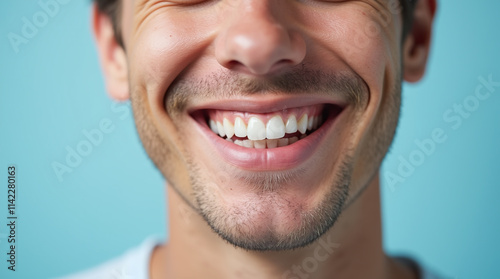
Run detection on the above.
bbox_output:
[209,114,322,140]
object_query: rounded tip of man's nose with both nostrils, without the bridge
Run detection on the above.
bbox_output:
[215,6,306,75]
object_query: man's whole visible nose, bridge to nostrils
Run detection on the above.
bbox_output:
[215,0,306,75]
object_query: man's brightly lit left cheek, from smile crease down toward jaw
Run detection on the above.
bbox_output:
[124,10,221,192]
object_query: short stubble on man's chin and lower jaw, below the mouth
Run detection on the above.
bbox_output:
[188,157,352,251]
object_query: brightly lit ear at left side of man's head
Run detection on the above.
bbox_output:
[92,4,130,101]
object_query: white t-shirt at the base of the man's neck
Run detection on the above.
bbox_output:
[59,237,441,279]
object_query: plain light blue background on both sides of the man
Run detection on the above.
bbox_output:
[0,0,500,279]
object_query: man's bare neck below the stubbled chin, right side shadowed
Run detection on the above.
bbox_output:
[150,176,416,279]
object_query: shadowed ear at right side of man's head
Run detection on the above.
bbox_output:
[403,0,436,82]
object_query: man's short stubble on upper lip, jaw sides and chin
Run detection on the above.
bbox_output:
[132,65,401,251]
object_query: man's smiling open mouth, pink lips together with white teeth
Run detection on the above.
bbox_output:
[190,98,344,171]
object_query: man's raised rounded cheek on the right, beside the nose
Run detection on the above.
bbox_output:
[299,4,399,98]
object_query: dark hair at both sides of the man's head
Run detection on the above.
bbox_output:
[93,0,418,47]
